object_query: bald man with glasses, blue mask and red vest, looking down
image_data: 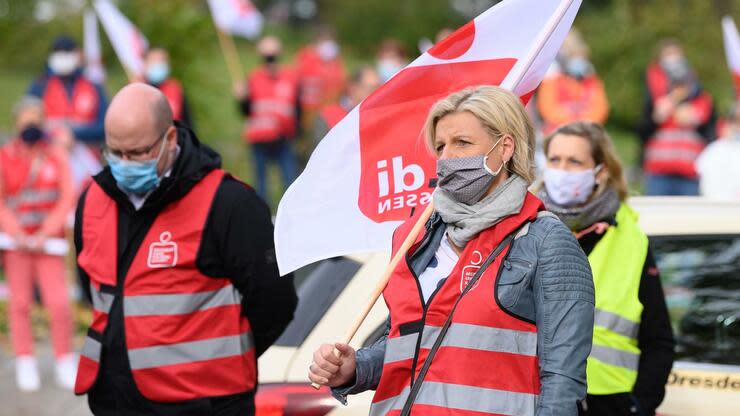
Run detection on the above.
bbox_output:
[74,84,297,415]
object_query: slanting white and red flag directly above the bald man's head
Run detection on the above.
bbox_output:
[94,0,149,76]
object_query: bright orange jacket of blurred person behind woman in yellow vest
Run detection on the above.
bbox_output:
[537,74,609,135]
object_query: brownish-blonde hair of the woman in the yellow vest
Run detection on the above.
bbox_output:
[544,121,629,201]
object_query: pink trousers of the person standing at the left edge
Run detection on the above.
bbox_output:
[4,251,72,358]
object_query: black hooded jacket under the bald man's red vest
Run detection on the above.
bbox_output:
[74,124,297,415]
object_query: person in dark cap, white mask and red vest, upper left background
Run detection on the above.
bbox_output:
[28,35,108,194]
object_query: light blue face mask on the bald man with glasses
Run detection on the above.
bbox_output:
[105,139,167,195]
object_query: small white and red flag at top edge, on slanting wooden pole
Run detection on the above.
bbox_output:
[208,0,263,39]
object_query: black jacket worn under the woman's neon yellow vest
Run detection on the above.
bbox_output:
[578,228,675,416]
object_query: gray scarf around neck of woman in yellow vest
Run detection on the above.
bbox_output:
[537,187,620,231]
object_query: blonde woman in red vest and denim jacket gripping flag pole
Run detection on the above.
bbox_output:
[309,86,594,416]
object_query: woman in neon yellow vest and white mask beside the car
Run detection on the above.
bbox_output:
[538,122,674,416]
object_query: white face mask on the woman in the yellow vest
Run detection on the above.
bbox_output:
[544,165,601,207]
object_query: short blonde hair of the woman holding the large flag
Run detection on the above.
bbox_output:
[424,85,535,184]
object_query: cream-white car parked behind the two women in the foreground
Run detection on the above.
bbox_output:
[256,197,740,416]
